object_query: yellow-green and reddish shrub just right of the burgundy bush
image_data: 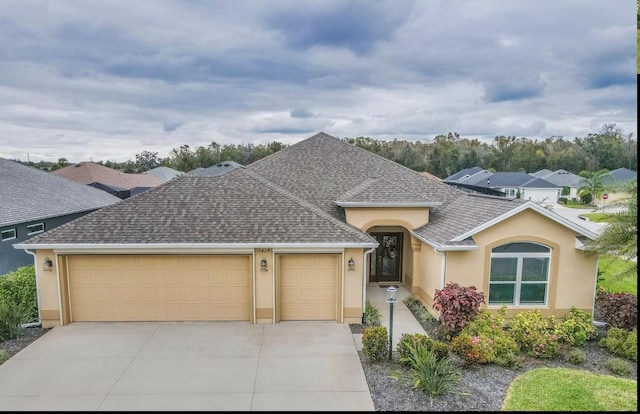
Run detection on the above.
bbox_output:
[461,305,520,367]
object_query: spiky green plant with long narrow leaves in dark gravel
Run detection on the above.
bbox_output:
[392,343,460,397]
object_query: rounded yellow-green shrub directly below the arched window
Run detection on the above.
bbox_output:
[508,309,558,358]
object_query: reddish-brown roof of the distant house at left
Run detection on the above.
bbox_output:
[51,162,163,190]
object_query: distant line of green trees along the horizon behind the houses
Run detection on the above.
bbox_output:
[20,124,638,178]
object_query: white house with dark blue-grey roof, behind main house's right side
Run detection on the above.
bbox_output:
[444,167,562,204]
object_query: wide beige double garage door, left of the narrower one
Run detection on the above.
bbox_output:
[68,255,251,321]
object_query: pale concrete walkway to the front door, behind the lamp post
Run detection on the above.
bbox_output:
[353,283,426,351]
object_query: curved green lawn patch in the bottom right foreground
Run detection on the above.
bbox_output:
[502,368,638,411]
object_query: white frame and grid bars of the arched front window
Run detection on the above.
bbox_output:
[487,242,551,306]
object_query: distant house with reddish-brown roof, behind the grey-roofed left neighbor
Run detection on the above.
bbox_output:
[51,162,164,199]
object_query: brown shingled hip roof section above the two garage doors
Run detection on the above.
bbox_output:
[25,169,375,245]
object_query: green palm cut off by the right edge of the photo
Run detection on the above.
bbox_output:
[590,180,638,278]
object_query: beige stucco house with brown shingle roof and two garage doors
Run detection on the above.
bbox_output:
[17,133,597,327]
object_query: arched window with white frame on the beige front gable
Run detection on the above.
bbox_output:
[489,242,551,305]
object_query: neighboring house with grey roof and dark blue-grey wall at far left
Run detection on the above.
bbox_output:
[0,158,120,275]
